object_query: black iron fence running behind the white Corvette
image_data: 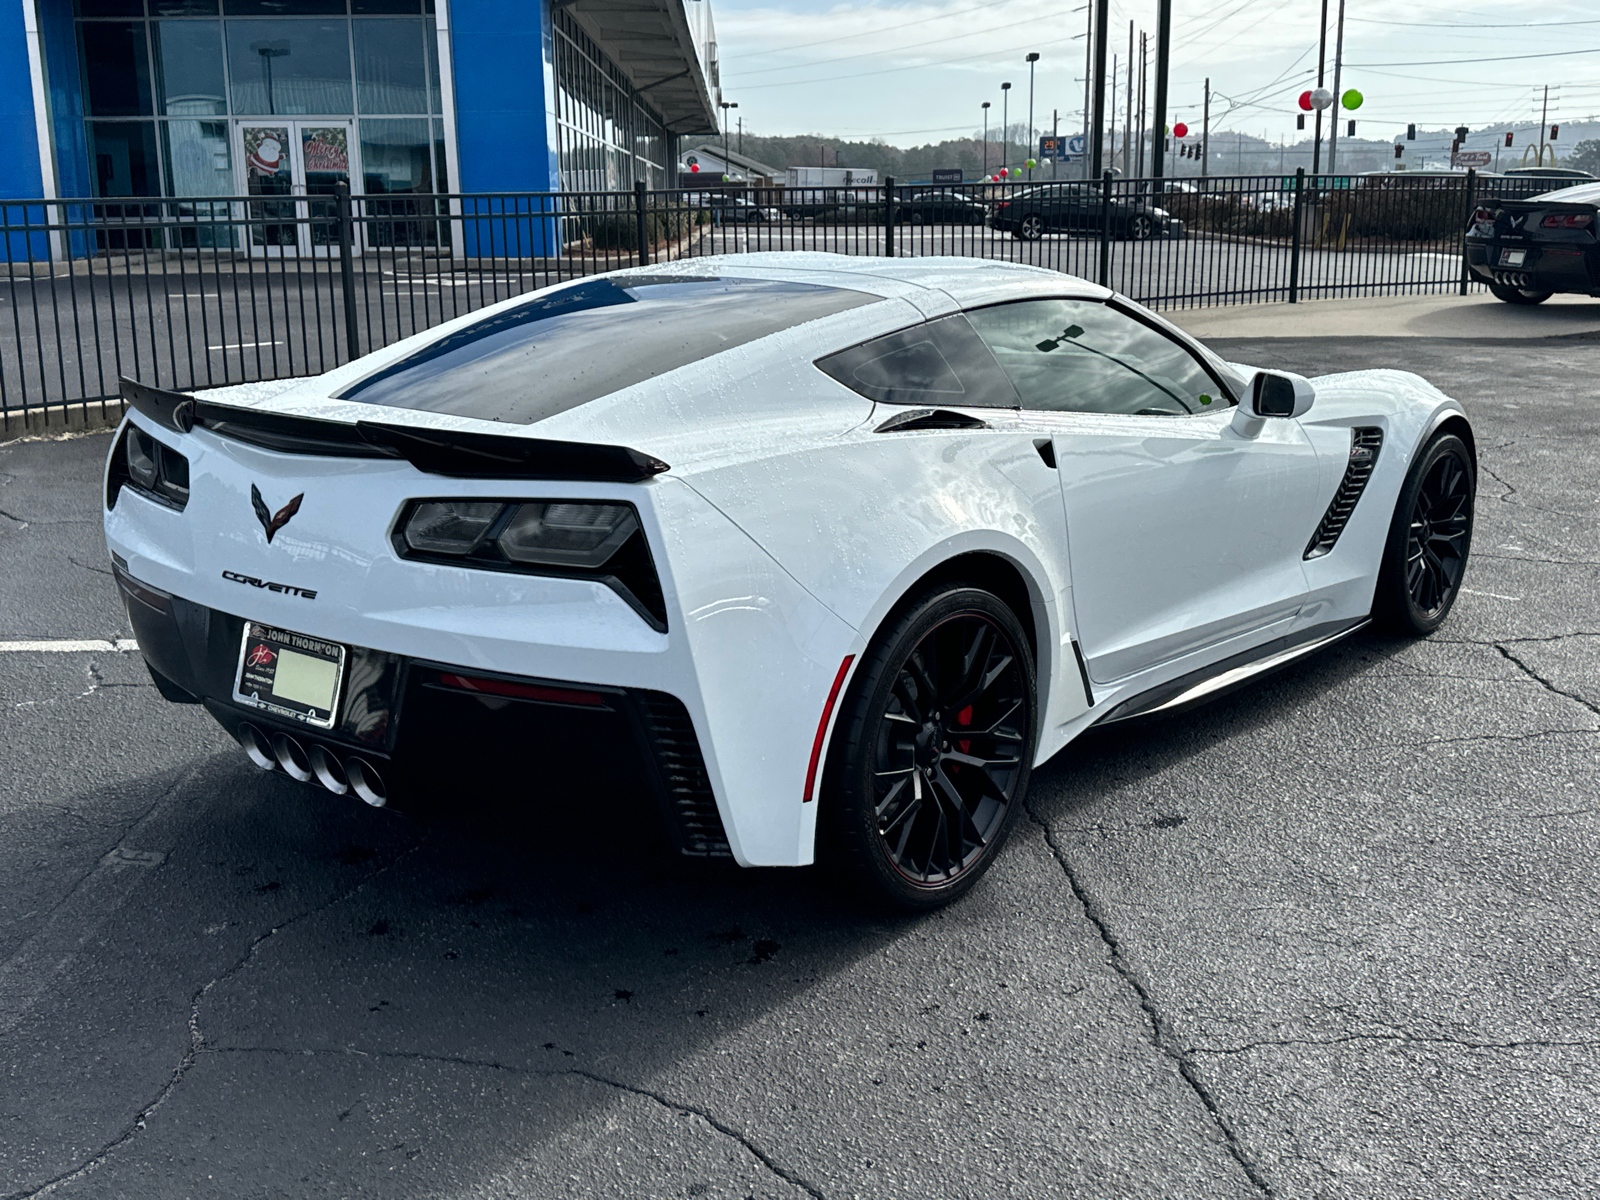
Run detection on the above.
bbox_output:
[0,173,1549,432]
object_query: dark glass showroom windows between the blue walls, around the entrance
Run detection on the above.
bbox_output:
[77,0,448,206]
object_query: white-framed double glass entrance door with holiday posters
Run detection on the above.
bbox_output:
[235,118,363,256]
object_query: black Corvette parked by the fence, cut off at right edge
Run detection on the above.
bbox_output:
[1467,182,1600,304]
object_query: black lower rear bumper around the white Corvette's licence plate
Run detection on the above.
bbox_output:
[114,565,731,858]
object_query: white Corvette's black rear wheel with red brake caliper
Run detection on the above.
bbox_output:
[818,582,1038,910]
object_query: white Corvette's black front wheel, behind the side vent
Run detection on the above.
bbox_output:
[1373,434,1477,637]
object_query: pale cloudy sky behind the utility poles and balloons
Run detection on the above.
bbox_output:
[712,0,1600,146]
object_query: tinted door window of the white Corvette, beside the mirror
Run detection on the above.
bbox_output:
[966,299,1232,416]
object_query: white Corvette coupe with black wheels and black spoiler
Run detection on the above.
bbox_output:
[106,253,1477,907]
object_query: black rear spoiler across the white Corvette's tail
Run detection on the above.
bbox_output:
[118,379,670,483]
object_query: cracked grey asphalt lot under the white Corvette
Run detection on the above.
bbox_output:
[0,338,1600,1200]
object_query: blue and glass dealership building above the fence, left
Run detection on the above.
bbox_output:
[0,0,720,209]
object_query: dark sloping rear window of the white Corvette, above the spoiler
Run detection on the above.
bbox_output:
[339,275,878,426]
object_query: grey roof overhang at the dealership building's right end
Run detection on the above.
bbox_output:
[566,0,722,134]
